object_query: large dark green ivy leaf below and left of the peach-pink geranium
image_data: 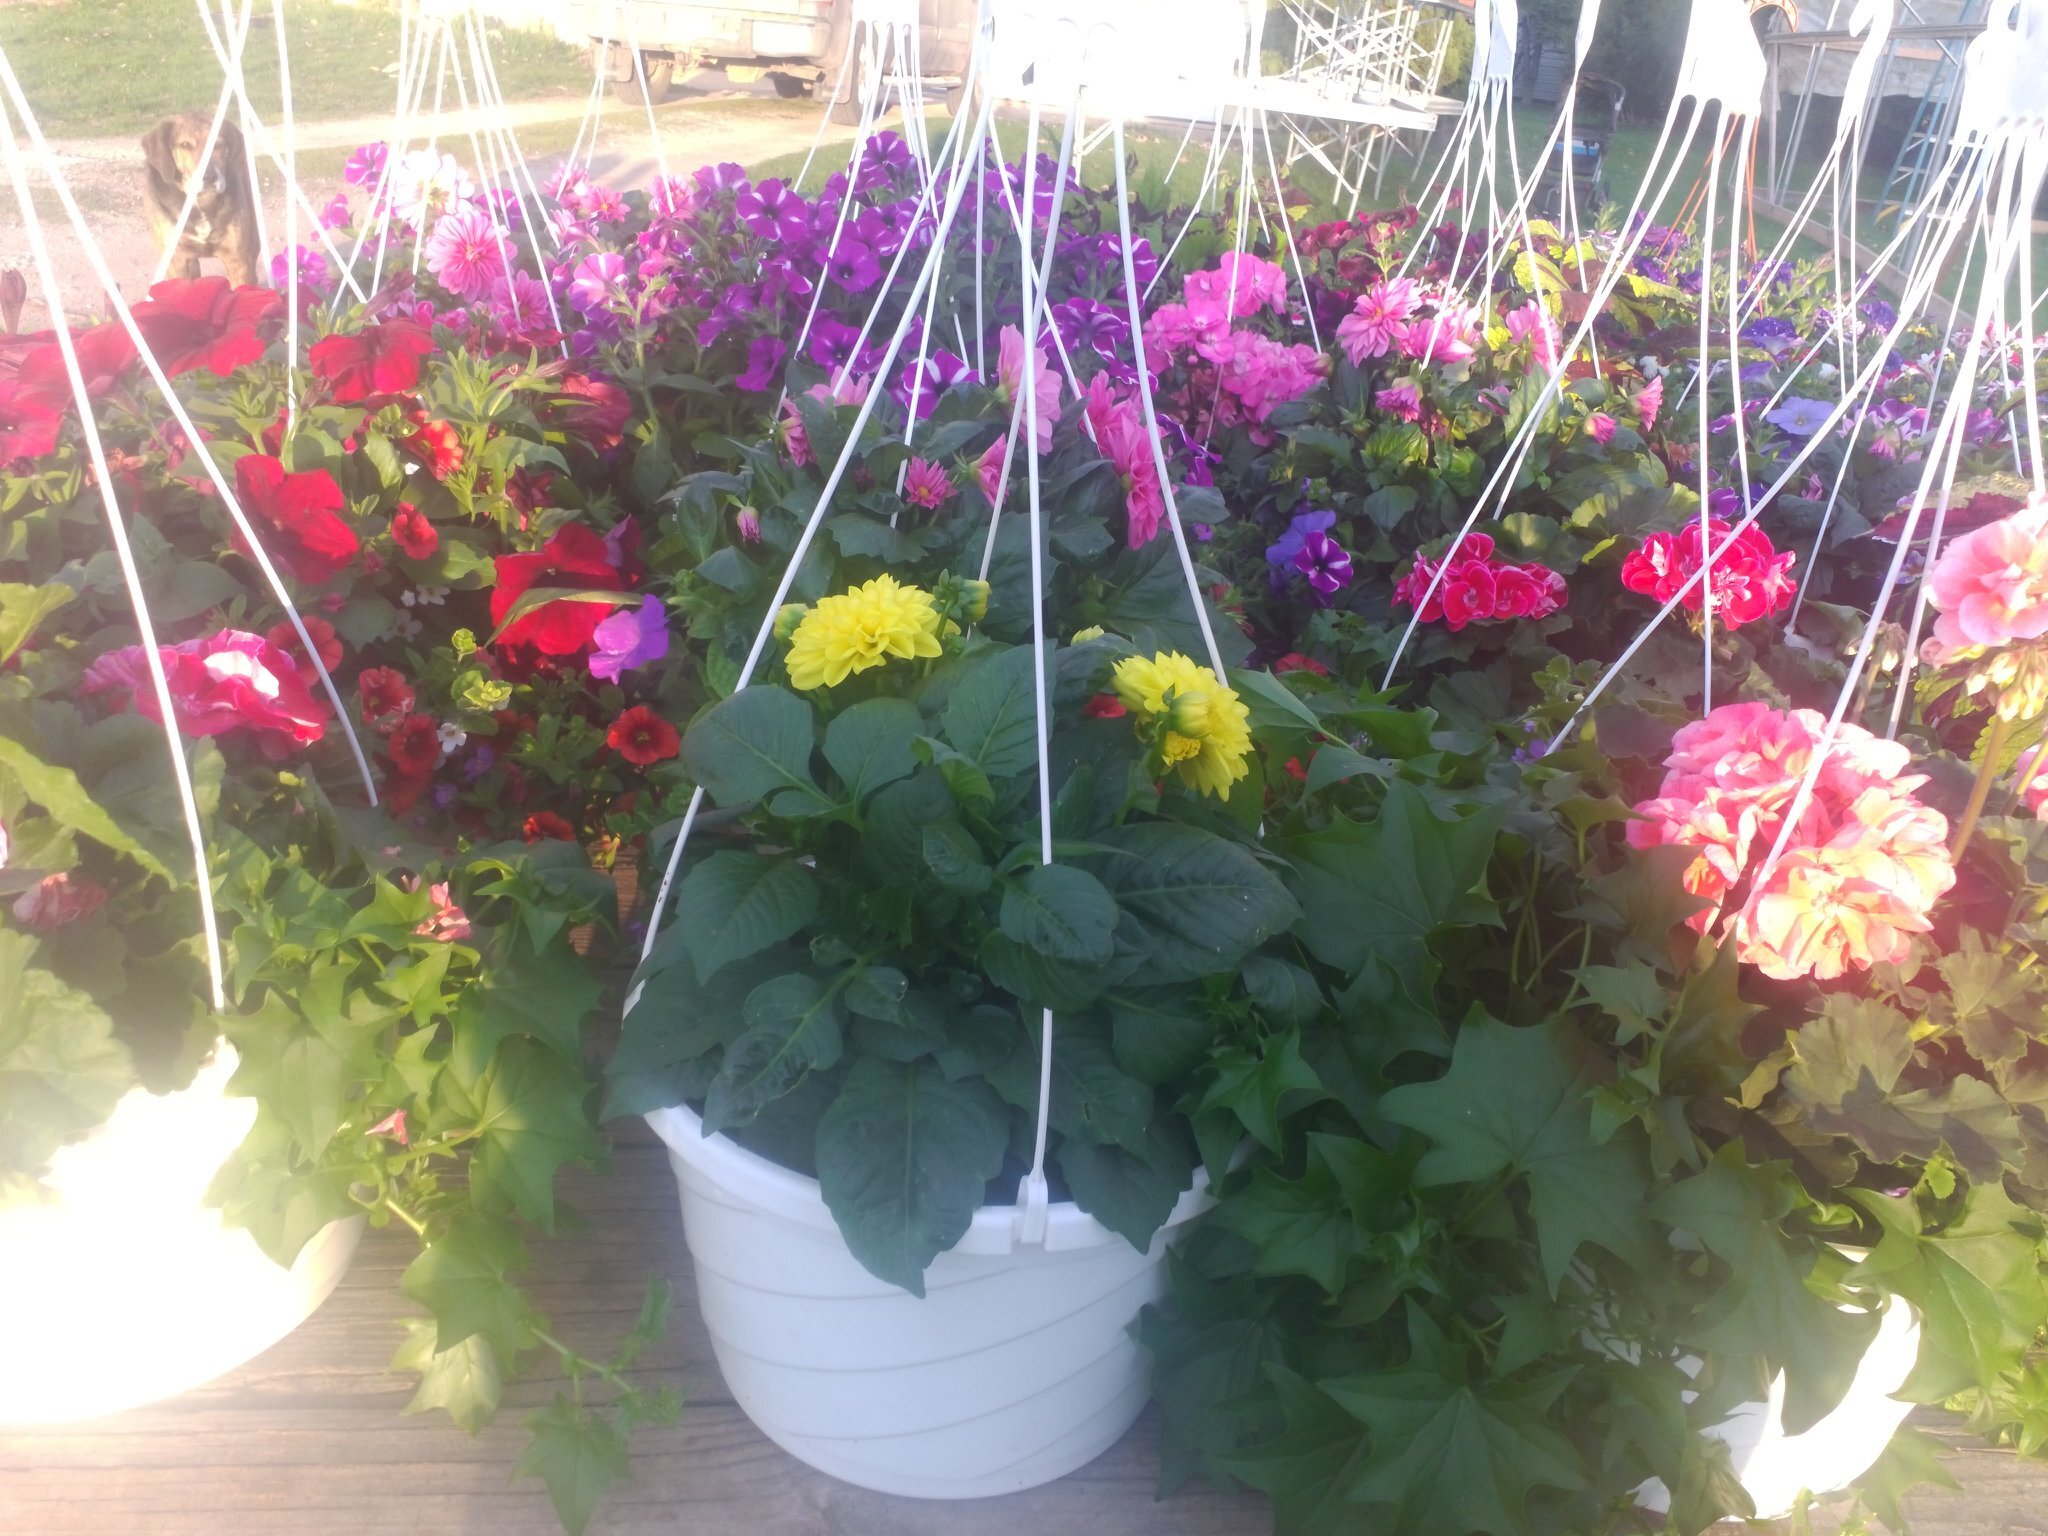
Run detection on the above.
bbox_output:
[1380,1018,1653,1294]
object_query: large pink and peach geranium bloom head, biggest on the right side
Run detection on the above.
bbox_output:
[1628,705,1956,981]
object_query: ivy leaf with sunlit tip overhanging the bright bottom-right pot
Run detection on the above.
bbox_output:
[1653,1141,1876,1434]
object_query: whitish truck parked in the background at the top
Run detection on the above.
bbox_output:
[555,0,977,123]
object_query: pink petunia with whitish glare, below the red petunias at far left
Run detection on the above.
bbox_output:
[82,629,328,760]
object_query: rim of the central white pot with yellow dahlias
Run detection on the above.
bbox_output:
[645,1104,1214,1253]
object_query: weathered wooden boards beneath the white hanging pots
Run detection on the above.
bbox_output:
[0,1135,2048,1536]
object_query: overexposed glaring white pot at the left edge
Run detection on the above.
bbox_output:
[0,1040,362,1425]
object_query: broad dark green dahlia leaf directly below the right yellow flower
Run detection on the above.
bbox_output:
[1077,821,1300,985]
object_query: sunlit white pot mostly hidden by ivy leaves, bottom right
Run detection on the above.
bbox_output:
[1636,1296,1919,1524]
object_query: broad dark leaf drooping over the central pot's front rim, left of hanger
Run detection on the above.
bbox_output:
[817,1057,1010,1296]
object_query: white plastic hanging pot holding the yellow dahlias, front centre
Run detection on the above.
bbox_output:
[647,1108,1208,1499]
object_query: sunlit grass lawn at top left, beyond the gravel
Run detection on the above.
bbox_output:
[0,0,590,137]
